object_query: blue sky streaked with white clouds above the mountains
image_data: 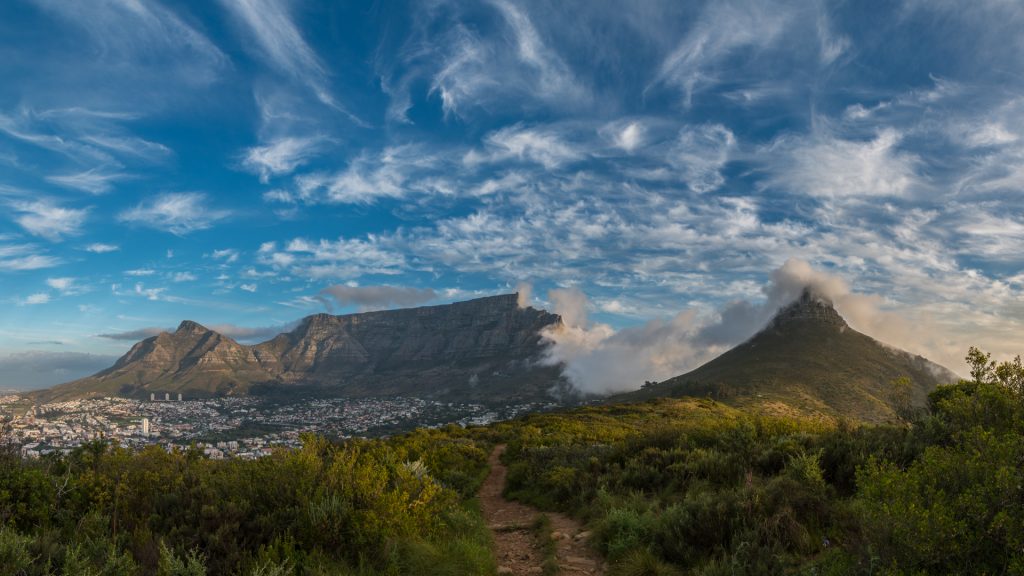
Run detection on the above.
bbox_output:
[0,0,1024,388]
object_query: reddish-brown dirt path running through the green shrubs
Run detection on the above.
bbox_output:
[480,445,604,576]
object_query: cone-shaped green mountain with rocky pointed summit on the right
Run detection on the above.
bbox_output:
[613,289,957,421]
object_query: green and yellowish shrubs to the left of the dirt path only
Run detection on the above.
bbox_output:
[0,427,495,576]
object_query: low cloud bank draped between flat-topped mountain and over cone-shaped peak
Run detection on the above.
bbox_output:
[544,259,966,395]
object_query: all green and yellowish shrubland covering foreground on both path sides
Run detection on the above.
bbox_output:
[0,349,1024,576]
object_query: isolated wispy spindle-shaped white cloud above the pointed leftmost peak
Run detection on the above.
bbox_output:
[118,192,230,236]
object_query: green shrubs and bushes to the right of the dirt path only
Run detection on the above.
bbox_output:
[505,349,1024,576]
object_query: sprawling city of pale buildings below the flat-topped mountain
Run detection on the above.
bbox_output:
[0,393,556,459]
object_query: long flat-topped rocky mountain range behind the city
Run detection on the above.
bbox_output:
[40,294,568,402]
